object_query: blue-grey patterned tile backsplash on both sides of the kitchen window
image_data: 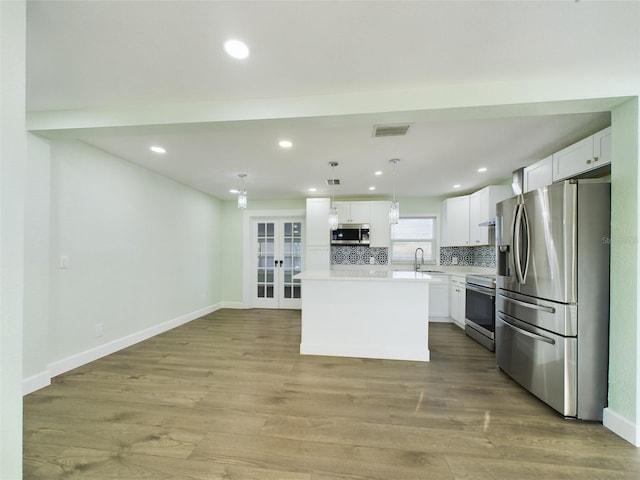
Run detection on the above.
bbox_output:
[331,245,496,268]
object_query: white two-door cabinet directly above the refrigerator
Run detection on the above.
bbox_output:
[552,127,611,182]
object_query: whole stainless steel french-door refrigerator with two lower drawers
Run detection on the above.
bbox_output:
[495,180,611,421]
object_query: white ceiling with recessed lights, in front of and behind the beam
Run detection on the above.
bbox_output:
[27,1,640,199]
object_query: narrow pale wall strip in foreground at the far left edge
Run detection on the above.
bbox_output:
[0,1,27,480]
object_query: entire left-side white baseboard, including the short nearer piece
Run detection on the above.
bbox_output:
[22,303,221,395]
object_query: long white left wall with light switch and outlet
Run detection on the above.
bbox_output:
[37,140,224,382]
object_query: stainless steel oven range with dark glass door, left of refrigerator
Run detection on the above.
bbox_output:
[464,275,496,352]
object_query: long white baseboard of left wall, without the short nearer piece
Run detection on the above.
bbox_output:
[48,304,220,384]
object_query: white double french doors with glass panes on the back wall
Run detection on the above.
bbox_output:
[251,219,302,309]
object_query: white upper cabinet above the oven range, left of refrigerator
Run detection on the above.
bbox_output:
[468,185,512,246]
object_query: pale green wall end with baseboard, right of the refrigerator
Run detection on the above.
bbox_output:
[603,97,640,447]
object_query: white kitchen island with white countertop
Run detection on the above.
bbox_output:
[296,270,439,362]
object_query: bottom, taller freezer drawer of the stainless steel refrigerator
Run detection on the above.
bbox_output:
[496,313,578,417]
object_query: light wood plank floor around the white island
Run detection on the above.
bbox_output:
[24,310,640,480]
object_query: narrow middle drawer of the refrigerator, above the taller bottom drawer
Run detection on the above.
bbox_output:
[496,290,578,337]
